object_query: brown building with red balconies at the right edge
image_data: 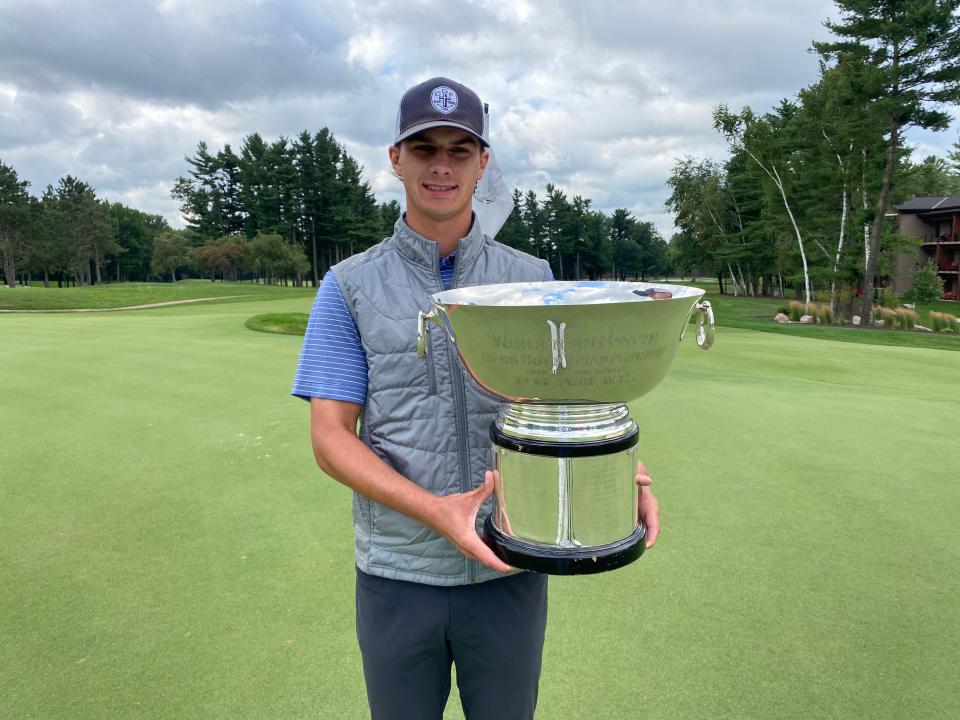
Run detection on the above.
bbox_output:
[893,196,960,300]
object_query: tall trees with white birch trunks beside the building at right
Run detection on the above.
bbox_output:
[667,0,960,320]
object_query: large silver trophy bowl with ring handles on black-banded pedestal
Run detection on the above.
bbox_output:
[417,281,715,575]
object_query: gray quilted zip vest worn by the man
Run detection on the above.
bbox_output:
[332,218,550,585]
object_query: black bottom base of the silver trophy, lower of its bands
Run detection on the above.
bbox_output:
[483,517,647,575]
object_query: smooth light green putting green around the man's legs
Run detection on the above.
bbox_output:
[0,297,960,720]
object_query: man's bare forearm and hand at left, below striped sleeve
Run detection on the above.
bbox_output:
[310,397,511,572]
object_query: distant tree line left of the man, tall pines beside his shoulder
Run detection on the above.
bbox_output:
[0,128,400,287]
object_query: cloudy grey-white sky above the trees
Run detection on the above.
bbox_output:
[0,0,960,237]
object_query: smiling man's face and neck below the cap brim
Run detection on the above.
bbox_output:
[390,128,488,227]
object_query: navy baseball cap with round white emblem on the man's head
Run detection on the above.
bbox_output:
[393,77,490,147]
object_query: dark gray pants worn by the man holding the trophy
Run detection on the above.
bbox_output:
[357,570,547,720]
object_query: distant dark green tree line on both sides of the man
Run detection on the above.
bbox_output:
[0,128,669,285]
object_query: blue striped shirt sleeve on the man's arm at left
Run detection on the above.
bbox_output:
[290,272,367,405]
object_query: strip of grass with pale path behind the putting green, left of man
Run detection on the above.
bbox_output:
[0,280,316,310]
